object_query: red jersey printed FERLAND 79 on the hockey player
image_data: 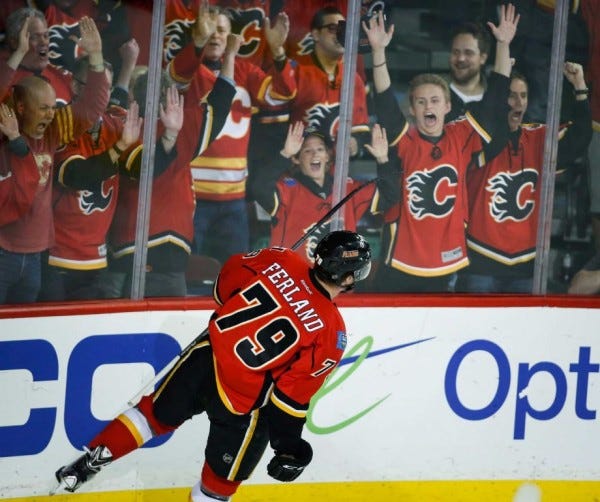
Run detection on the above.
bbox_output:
[209,248,346,418]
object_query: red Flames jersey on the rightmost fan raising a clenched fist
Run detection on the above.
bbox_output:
[467,95,592,276]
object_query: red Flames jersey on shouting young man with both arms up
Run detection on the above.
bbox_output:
[380,117,484,277]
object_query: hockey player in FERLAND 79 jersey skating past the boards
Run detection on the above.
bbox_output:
[56,230,371,502]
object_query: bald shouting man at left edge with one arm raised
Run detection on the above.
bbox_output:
[0,18,109,303]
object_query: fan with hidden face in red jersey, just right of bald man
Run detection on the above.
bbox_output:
[38,54,142,301]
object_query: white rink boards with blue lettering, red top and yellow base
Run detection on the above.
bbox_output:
[0,295,600,502]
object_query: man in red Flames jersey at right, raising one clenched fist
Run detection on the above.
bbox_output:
[456,62,592,293]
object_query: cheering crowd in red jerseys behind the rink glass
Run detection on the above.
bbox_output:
[0,0,600,304]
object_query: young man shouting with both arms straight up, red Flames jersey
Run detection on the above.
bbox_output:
[363,4,519,292]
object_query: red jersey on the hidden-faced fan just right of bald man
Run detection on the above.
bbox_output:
[48,107,125,270]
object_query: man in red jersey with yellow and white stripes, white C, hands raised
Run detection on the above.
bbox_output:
[169,7,296,263]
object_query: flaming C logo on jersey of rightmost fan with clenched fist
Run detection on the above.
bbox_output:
[485,169,538,223]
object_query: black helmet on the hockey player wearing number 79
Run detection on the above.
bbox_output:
[315,230,371,286]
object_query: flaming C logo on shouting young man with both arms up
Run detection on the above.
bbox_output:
[406,165,458,220]
